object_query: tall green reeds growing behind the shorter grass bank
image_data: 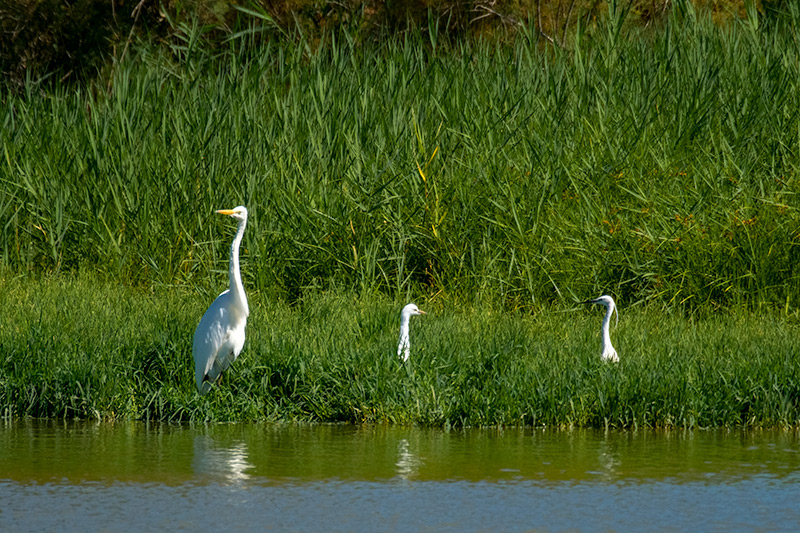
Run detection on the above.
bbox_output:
[0,6,800,310]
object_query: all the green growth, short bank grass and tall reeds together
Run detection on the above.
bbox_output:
[0,2,800,427]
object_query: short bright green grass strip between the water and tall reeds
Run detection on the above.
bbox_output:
[0,277,800,427]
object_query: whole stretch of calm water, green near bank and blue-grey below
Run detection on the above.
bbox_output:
[0,421,800,531]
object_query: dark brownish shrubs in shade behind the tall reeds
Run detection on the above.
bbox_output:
[0,0,768,88]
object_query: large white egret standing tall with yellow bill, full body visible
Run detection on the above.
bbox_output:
[192,205,250,395]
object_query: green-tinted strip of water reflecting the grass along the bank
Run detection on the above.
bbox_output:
[0,420,800,485]
